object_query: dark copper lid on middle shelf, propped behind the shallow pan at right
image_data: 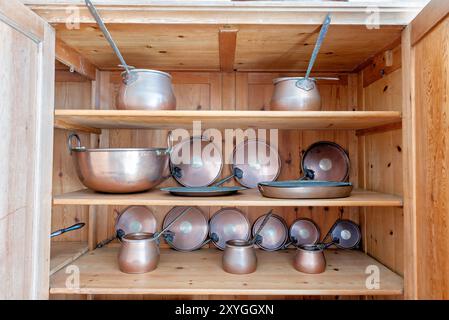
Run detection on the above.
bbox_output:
[301,141,350,181]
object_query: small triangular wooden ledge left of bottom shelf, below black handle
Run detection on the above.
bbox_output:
[50,241,88,275]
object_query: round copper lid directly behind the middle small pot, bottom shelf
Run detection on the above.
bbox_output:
[209,208,250,250]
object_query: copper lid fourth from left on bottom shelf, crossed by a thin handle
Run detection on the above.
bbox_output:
[252,214,288,251]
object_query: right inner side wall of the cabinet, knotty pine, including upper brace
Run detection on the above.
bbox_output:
[358,40,404,298]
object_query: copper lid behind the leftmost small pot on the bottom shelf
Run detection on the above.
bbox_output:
[115,206,157,235]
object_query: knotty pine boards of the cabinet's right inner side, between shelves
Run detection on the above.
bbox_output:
[361,69,404,274]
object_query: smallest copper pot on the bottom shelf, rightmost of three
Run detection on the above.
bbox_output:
[293,245,326,274]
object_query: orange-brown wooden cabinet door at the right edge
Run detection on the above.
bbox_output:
[412,18,449,299]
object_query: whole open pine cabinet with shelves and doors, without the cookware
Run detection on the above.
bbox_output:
[0,0,449,299]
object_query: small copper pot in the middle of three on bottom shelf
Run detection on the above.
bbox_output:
[222,240,257,274]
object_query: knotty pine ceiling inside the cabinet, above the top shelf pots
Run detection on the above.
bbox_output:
[48,21,402,72]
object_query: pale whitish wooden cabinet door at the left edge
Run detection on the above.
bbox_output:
[0,0,55,300]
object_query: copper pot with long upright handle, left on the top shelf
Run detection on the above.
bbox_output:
[85,0,176,110]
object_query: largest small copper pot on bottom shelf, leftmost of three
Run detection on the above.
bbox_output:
[118,232,159,273]
